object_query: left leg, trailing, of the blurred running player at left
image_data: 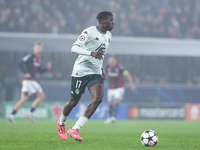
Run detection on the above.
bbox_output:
[7,92,29,123]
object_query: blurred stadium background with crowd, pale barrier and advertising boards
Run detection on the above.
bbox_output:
[0,0,200,120]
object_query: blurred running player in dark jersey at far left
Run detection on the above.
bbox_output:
[7,42,52,123]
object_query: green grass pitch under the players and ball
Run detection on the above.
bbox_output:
[0,119,200,150]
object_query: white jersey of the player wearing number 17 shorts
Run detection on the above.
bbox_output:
[72,26,112,77]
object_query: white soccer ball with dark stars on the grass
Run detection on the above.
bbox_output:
[141,130,158,146]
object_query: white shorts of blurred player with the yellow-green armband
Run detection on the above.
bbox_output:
[107,88,124,102]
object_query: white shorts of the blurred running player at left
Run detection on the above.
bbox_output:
[21,80,43,96]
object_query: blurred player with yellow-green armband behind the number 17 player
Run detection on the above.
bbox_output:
[105,56,136,124]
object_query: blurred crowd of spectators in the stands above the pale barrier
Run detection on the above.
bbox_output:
[0,0,200,39]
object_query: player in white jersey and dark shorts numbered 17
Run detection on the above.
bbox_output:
[57,11,114,141]
